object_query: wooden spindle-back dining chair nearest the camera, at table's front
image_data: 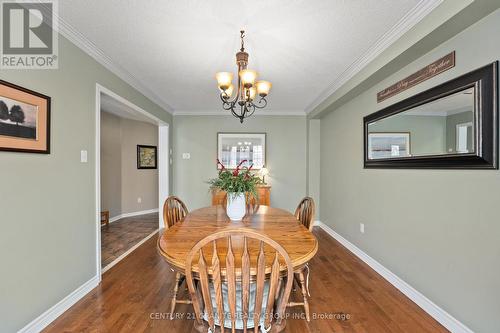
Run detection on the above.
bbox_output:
[186,228,293,333]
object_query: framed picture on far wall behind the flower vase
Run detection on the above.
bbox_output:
[217,133,266,170]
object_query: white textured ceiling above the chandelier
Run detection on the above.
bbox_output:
[59,0,426,112]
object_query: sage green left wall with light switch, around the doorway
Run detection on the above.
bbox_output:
[0,37,171,332]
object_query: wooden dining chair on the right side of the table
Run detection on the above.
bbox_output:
[288,197,315,321]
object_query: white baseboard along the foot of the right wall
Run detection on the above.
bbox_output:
[314,221,473,333]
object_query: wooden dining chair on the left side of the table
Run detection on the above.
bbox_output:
[163,196,191,318]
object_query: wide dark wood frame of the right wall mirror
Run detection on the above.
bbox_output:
[363,61,498,169]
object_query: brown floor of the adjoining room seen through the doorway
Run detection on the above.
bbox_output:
[101,213,159,268]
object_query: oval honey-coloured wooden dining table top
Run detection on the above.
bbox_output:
[158,205,318,272]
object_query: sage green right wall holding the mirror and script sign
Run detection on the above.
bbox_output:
[320,10,500,332]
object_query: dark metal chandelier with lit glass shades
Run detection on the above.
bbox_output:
[215,30,271,123]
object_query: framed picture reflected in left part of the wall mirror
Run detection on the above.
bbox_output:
[368,132,411,159]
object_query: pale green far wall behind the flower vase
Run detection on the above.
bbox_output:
[173,115,307,212]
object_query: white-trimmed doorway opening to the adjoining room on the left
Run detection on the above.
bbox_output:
[95,84,169,277]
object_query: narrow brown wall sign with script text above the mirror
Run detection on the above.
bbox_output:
[377,51,455,103]
